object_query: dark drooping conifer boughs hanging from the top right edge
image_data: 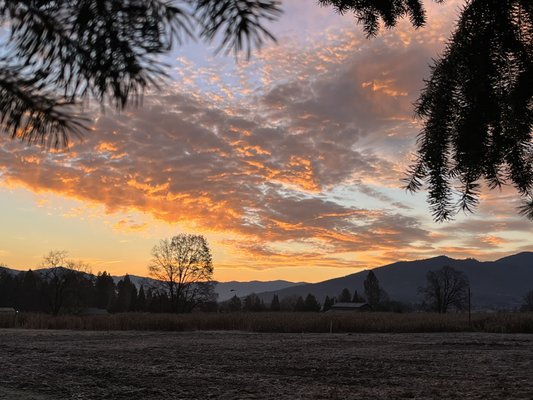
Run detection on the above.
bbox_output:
[320,0,533,221]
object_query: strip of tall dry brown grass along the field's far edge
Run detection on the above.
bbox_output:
[0,313,533,333]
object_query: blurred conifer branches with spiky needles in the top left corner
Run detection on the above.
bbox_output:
[0,0,281,147]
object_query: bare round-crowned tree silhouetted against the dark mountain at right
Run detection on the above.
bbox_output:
[420,265,470,314]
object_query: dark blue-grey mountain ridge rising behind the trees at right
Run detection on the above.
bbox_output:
[254,253,533,308]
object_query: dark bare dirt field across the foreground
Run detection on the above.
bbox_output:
[0,330,533,400]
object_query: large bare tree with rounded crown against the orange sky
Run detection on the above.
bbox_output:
[148,234,213,312]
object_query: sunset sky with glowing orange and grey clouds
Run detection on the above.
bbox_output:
[0,0,533,282]
